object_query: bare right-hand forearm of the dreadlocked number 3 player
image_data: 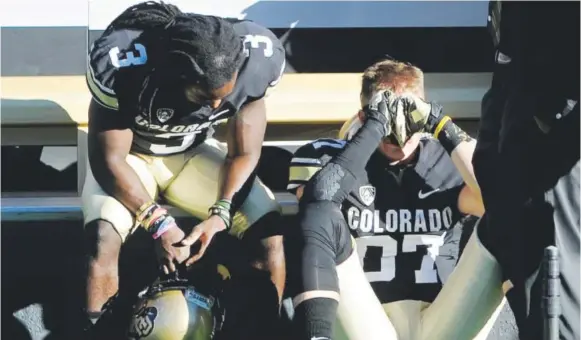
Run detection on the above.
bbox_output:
[220,151,260,201]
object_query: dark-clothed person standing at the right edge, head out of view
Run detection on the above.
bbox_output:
[473,1,581,339]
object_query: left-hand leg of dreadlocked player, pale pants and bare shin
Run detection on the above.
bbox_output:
[82,155,157,322]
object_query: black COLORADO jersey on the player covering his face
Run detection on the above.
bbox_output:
[288,138,464,303]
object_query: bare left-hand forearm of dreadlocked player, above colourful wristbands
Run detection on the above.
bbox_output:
[91,159,152,215]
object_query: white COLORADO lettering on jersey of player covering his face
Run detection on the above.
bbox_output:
[347,207,453,233]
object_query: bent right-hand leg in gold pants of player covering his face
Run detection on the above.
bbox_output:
[421,220,504,340]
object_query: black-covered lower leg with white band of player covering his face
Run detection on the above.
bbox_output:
[285,201,345,340]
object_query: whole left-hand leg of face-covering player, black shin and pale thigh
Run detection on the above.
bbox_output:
[286,201,389,340]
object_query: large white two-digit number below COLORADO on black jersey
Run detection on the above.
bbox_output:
[356,235,444,283]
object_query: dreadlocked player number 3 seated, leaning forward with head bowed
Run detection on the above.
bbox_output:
[82,2,285,334]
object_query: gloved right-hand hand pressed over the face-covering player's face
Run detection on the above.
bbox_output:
[388,93,444,134]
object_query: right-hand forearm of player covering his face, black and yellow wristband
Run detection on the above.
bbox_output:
[434,120,481,197]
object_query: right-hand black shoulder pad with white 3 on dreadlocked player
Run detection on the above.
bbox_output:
[228,20,285,109]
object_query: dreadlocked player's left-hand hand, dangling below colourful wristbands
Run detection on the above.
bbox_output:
[154,225,190,275]
